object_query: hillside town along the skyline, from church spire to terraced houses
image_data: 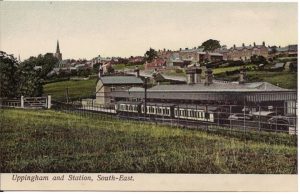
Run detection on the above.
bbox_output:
[26,41,298,77]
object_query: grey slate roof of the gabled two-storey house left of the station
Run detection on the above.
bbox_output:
[100,76,143,85]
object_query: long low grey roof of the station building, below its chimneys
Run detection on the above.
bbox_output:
[148,81,287,92]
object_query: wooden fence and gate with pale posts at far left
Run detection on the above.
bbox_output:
[0,96,51,109]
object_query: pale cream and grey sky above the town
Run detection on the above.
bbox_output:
[0,1,298,60]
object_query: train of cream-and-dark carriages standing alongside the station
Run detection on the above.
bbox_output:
[114,101,294,131]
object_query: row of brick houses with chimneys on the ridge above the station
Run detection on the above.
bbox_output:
[145,42,298,70]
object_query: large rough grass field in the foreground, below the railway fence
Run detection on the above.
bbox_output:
[0,109,297,174]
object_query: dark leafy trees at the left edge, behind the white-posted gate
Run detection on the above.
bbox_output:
[0,54,58,97]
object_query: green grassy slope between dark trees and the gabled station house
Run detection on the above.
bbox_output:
[44,78,97,100]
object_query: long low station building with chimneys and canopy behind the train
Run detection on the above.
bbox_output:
[110,68,297,115]
